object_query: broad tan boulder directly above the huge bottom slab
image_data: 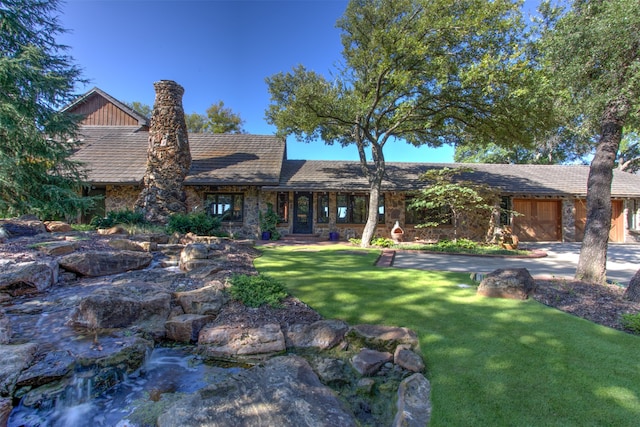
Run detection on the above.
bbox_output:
[198,324,286,362]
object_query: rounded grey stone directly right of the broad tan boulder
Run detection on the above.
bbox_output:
[285,319,349,350]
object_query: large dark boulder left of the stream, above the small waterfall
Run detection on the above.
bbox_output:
[71,282,171,335]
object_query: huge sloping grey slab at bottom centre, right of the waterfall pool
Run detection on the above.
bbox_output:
[157,356,358,427]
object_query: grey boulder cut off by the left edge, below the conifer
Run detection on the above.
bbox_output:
[0,262,58,296]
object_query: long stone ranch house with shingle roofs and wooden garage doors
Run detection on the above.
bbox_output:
[65,88,640,242]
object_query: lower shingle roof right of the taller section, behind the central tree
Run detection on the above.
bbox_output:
[265,160,640,197]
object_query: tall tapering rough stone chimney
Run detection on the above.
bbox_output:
[136,80,191,223]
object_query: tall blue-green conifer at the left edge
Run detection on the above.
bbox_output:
[0,0,93,219]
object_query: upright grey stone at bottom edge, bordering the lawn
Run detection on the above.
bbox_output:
[392,374,431,427]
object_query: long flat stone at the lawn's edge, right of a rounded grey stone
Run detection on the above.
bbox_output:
[347,324,419,352]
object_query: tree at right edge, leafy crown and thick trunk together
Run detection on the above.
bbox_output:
[542,0,640,283]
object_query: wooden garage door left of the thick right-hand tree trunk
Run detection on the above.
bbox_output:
[513,199,562,242]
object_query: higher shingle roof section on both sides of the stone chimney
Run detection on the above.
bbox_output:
[73,126,285,185]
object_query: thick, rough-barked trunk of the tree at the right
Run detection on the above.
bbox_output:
[575,99,629,283]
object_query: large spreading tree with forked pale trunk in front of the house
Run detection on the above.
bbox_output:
[266,0,549,246]
